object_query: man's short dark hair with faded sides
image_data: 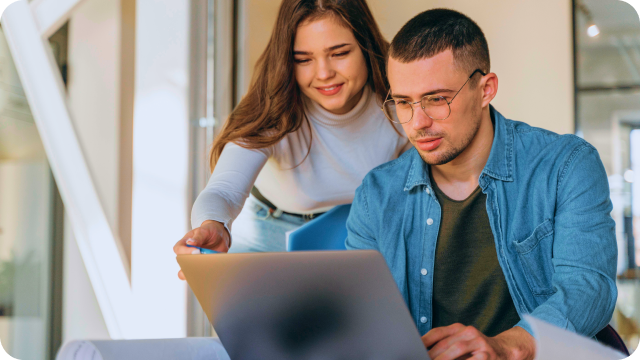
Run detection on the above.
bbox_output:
[389,9,491,79]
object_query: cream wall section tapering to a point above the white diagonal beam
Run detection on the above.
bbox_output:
[68,0,120,233]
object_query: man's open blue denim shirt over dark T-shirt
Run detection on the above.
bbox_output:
[346,108,617,337]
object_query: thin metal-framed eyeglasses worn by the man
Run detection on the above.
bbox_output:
[381,69,487,124]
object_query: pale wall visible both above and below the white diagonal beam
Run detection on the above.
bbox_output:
[62,0,120,342]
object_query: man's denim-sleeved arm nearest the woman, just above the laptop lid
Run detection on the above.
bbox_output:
[345,178,378,250]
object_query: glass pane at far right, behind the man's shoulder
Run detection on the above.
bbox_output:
[574,0,640,353]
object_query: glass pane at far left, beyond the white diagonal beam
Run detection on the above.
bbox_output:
[0,29,53,359]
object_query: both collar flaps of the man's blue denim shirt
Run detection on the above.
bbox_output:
[404,105,514,191]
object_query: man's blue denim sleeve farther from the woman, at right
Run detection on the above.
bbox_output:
[517,144,618,337]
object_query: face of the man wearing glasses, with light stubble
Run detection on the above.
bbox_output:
[387,50,482,165]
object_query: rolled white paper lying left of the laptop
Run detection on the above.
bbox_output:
[56,338,229,360]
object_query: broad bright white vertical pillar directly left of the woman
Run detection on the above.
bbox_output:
[131,0,191,338]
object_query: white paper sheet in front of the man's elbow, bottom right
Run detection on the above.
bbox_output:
[524,315,627,360]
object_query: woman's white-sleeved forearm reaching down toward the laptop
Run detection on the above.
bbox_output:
[191,143,271,232]
